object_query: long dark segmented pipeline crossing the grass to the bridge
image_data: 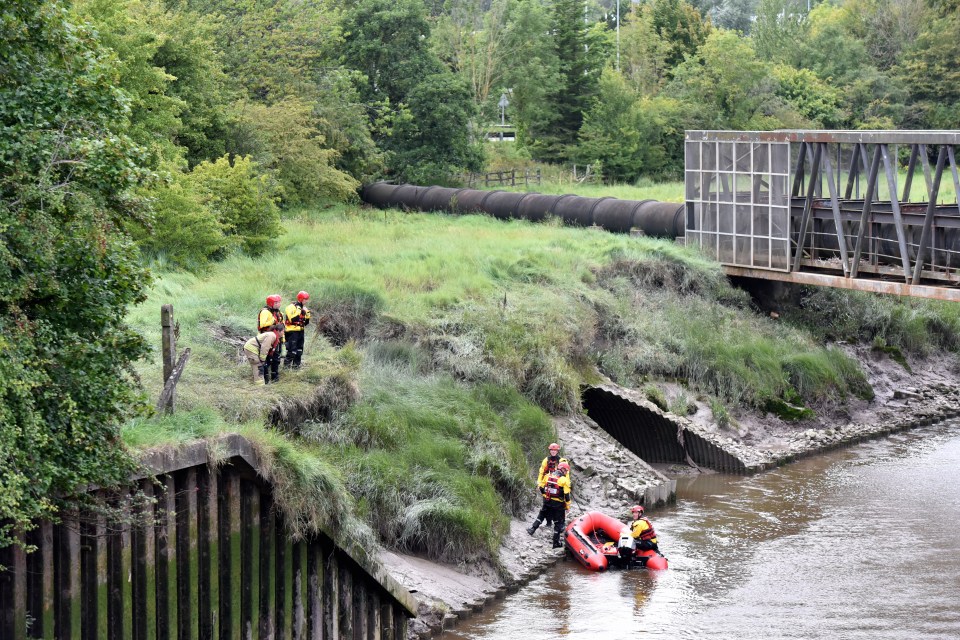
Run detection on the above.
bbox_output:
[361,182,685,238]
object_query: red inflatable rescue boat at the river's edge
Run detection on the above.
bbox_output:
[566,511,667,571]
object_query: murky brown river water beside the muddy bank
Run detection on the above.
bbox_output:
[442,420,960,640]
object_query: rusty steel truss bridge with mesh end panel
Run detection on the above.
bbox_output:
[685,131,960,301]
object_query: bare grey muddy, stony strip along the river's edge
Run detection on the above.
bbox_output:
[381,347,960,638]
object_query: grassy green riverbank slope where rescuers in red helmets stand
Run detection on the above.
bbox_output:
[124,202,928,559]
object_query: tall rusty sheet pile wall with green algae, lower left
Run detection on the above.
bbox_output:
[0,440,413,640]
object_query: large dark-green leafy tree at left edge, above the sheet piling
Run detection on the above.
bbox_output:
[0,0,147,545]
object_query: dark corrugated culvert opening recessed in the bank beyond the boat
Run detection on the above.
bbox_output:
[583,385,749,473]
